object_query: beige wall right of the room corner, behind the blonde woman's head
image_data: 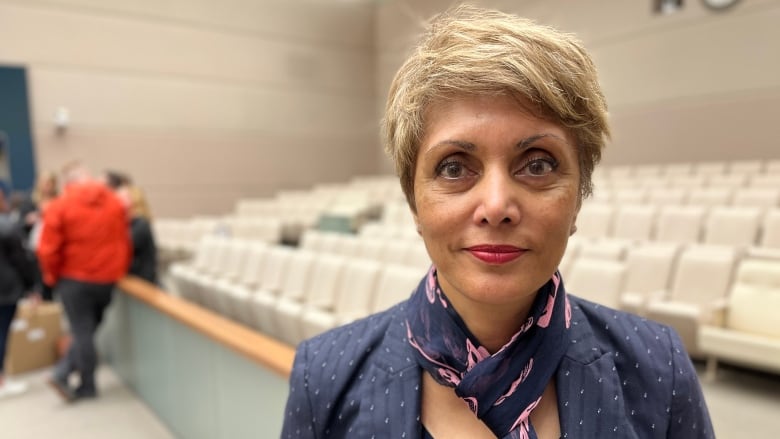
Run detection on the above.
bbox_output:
[376,0,780,168]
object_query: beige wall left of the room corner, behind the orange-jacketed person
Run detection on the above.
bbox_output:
[0,0,379,216]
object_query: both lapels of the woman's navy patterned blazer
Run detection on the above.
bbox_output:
[366,301,637,438]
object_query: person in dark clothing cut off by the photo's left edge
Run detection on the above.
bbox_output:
[0,187,35,399]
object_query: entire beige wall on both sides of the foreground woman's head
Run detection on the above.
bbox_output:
[0,0,780,216]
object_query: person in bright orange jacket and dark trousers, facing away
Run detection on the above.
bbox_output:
[36,162,132,401]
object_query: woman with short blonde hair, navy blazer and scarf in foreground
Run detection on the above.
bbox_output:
[282,7,713,439]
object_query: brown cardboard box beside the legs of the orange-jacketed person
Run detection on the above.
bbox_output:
[5,301,62,375]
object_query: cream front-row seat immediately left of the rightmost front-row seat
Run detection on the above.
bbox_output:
[645,245,739,358]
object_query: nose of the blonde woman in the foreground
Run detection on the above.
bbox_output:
[474,171,520,226]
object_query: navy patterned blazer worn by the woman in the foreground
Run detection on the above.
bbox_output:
[282,294,714,439]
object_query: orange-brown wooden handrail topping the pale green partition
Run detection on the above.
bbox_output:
[117,276,295,378]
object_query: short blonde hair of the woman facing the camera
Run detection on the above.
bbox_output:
[382,5,609,211]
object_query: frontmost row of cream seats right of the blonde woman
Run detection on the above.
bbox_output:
[560,240,780,373]
